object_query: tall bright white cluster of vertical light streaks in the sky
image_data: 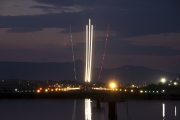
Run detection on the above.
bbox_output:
[85,19,93,82]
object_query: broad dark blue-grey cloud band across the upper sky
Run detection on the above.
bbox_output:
[0,0,180,37]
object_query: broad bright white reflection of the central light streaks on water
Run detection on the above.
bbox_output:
[85,99,92,120]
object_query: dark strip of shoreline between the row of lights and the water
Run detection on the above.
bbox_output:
[0,91,180,102]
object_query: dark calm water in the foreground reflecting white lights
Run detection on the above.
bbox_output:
[0,99,180,120]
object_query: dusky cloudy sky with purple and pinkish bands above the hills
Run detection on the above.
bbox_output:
[0,0,180,72]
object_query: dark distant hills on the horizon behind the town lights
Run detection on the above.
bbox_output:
[0,60,180,83]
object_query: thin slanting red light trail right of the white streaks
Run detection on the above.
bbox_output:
[98,24,109,80]
